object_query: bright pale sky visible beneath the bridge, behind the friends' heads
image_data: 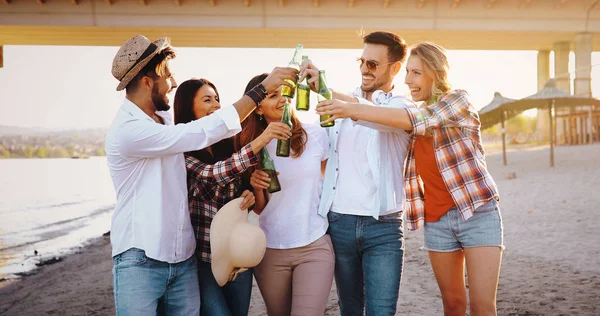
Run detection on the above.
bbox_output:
[0,46,600,129]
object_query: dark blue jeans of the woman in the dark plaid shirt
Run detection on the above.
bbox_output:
[198,261,252,316]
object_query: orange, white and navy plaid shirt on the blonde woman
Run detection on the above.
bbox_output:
[405,90,499,230]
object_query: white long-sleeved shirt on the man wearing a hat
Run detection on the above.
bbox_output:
[106,99,241,263]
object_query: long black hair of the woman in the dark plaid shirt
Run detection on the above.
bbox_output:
[173,78,236,164]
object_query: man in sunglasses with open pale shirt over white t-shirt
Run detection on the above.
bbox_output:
[300,32,414,316]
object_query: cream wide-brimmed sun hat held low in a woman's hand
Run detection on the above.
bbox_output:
[210,198,267,286]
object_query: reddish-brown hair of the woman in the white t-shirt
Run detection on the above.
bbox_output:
[239,73,307,158]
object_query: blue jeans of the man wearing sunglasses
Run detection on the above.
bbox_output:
[327,212,404,316]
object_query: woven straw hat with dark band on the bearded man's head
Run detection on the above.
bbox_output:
[112,35,169,91]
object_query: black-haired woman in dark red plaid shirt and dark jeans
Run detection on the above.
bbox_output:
[174,79,291,316]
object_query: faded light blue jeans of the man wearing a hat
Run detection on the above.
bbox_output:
[113,248,200,316]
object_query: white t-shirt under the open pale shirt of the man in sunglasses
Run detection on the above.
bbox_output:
[331,119,377,216]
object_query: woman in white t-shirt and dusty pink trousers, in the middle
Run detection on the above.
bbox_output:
[240,74,335,316]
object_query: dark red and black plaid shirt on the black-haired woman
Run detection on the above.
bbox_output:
[185,144,258,263]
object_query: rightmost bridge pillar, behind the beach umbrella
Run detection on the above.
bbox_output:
[574,33,594,143]
